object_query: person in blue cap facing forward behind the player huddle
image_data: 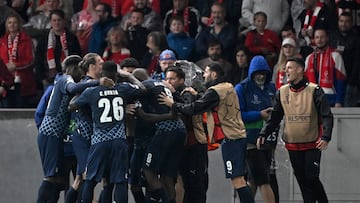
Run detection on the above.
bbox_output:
[152,49,176,80]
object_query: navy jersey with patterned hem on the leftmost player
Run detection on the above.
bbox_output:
[39,74,75,137]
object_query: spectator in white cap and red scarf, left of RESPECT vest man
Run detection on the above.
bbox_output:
[272,37,302,89]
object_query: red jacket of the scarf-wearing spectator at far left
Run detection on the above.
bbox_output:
[0,32,36,96]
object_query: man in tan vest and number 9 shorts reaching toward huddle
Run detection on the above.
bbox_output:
[159,63,254,203]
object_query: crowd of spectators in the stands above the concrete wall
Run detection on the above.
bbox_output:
[0,0,360,108]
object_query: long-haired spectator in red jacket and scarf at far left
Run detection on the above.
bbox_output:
[0,14,37,108]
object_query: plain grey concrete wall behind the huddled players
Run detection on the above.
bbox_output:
[0,108,360,203]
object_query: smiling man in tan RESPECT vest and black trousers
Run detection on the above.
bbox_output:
[257,58,333,202]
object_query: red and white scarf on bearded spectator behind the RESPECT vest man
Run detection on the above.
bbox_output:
[305,47,335,88]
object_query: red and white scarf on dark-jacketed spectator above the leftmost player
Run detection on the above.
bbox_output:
[47,29,69,69]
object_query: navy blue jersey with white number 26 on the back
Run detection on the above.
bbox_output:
[75,83,142,145]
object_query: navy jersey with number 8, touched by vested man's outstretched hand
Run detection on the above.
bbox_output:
[141,79,185,134]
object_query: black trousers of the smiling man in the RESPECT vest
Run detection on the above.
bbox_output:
[289,149,328,203]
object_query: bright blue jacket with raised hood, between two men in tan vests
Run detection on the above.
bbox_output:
[235,56,276,144]
